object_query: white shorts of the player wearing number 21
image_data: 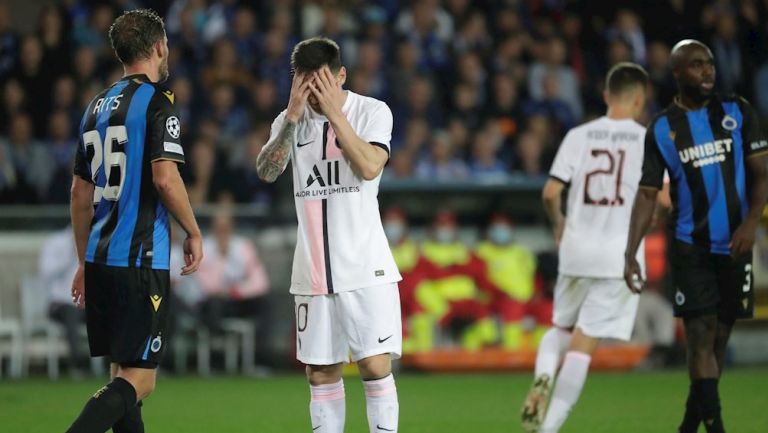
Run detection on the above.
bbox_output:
[552,275,640,340]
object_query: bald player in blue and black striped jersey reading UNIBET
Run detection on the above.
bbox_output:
[625,39,768,433]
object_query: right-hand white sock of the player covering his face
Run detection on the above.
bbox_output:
[363,374,400,433]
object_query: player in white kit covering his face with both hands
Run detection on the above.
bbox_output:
[256,38,402,433]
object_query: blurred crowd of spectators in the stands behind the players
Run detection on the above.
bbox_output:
[0,0,768,204]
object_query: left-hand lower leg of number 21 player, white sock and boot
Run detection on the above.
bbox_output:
[522,326,571,432]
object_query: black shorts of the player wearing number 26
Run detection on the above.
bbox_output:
[85,263,171,368]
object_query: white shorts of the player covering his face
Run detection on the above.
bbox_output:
[295,283,403,365]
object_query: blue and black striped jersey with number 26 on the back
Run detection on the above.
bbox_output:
[74,74,184,269]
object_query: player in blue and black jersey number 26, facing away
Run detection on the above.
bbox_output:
[68,9,203,433]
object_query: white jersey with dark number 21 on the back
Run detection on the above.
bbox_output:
[549,116,645,278]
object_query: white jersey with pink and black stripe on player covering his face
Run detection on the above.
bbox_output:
[270,91,401,295]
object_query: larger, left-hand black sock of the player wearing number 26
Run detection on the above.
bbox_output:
[67,377,136,433]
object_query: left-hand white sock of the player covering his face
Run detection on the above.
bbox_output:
[309,379,346,433]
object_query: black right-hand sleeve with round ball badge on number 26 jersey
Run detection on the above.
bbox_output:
[145,89,184,164]
